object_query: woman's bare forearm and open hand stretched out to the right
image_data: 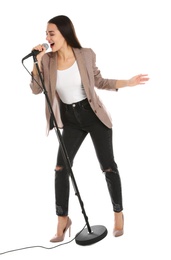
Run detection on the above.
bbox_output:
[115,74,149,89]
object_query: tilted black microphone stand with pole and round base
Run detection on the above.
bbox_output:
[22,55,107,245]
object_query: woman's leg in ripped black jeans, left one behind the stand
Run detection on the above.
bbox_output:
[55,126,87,237]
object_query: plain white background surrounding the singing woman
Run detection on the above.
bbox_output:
[0,0,171,260]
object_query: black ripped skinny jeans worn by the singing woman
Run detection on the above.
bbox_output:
[55,99,123,216]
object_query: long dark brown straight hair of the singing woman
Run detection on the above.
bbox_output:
[48,15,82,49]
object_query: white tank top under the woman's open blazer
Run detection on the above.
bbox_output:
[56,61,86,104]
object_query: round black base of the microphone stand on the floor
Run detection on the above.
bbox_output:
[75,225,107,246]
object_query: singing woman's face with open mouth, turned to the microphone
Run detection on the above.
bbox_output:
[46,23,66,52]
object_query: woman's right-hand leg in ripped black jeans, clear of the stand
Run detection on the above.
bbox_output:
[90,123,123,235]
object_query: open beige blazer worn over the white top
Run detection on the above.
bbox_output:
[30,48,117,134]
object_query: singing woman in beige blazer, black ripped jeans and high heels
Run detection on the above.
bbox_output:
[30,15,149,242]
